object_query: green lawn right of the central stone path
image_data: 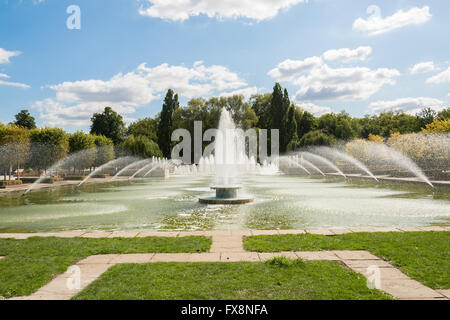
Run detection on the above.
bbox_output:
[244,232,450,289]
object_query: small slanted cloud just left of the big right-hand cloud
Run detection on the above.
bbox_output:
[268,57,323,81]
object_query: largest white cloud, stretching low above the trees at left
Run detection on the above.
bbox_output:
[34,61,253,127]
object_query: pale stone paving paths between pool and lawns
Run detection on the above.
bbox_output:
[0,227,450,300]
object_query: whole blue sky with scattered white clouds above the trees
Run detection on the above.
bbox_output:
[0,0,450,132]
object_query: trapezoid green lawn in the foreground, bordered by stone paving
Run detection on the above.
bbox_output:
[74,259,390,300]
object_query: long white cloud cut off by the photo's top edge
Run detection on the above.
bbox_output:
[139,0,308,21]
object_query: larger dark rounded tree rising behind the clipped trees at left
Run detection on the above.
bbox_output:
[91,107,125,145]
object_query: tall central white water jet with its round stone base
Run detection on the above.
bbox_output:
[199,109,256,204]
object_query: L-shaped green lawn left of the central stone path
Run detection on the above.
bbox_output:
[0,237,211,298]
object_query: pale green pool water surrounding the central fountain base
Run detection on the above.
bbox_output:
[0,175,450,232]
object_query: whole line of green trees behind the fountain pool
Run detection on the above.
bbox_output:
[0,83,450,179]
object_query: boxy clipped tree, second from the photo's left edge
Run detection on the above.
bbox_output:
[29,128,69,175]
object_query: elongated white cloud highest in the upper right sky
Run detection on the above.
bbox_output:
[353,6,432,36]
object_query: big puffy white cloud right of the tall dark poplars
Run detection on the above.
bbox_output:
[294,65,400,101]
